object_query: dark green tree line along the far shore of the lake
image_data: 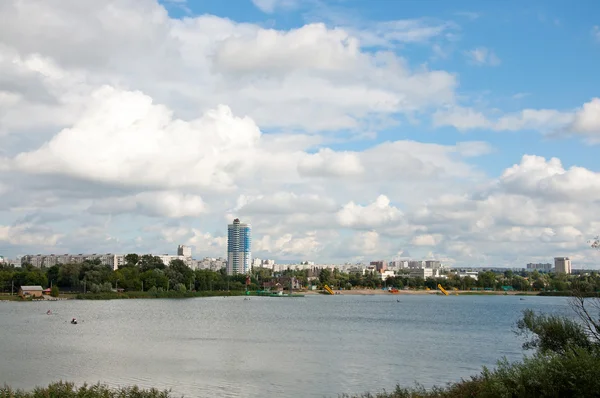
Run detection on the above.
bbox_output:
[0,254,600,293]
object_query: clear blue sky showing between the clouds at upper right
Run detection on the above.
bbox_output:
[163,0,600,175]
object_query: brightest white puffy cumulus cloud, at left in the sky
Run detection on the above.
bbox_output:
[5,86,260,189]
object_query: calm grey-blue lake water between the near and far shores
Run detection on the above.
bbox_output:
[0,295,569,397]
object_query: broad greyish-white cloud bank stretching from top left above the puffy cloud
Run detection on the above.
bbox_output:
[0,0,456,132]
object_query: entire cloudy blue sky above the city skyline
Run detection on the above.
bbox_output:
[0,0,600,268]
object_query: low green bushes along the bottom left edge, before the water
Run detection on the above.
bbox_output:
[0,381,173,398]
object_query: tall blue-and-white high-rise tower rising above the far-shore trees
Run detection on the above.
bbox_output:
[227,218,252,275]
